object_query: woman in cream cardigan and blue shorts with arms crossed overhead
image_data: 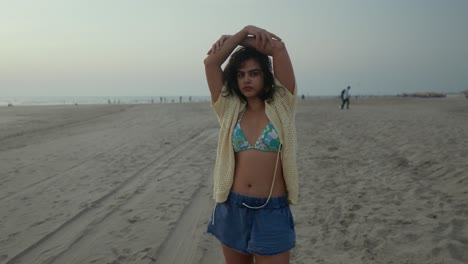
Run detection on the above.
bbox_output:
[204,26,298,264]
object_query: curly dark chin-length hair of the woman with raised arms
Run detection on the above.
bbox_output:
[223,47,275,102]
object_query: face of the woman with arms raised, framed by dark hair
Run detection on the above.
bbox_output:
[237,59,265,98]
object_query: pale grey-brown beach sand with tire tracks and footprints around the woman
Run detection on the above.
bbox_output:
[0,97,468,264]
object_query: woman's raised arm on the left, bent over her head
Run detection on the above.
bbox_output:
[204,26,280,103]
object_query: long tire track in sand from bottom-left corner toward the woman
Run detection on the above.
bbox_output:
[6,129,215,264]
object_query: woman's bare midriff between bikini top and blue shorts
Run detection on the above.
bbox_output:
[231,149,287,198]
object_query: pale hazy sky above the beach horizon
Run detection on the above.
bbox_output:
[0,0,468,97]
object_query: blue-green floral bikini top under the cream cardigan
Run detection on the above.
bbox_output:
[232,108,280,152]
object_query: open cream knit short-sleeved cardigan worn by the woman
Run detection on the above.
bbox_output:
[212,79,298,204]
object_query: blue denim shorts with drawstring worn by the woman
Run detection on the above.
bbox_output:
[208,192,296,255]
